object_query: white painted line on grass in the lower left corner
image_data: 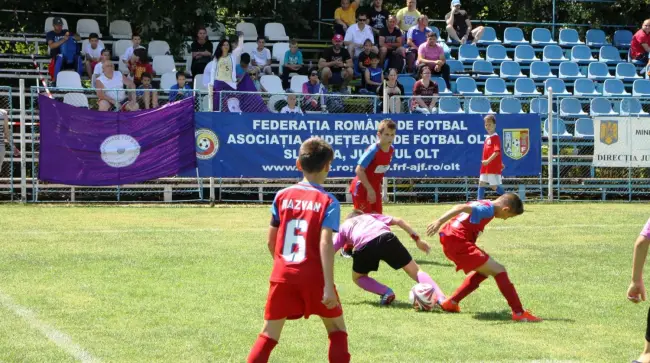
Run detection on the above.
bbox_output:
[0,291,99,362]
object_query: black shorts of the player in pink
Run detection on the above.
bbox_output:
[352,233,413,275]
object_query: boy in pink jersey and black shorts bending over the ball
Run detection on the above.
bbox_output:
[334,210,445,305]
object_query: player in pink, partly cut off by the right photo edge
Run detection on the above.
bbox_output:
[627,219,650,363]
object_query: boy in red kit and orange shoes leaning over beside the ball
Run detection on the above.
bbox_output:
[427,193,542,322]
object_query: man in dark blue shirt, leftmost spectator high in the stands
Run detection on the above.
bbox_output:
[45,17,83,81]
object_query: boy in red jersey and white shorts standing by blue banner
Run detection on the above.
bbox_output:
[478,115,504,200]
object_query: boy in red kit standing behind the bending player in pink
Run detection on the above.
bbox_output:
[350,119,397,214]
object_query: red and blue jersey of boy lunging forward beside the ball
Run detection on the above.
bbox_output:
[440,200,494,243]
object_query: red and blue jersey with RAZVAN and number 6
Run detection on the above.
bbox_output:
[270,182,341,286]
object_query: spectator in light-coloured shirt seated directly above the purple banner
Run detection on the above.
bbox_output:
[95,60,138,111]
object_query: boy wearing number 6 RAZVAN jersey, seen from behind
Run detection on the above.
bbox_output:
[248,137,350,363]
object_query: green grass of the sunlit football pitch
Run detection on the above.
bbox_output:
[0,204,649,362]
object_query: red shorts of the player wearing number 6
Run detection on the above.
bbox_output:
[264,282,343,320]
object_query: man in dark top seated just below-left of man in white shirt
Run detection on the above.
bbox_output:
[318,34,354,89]
